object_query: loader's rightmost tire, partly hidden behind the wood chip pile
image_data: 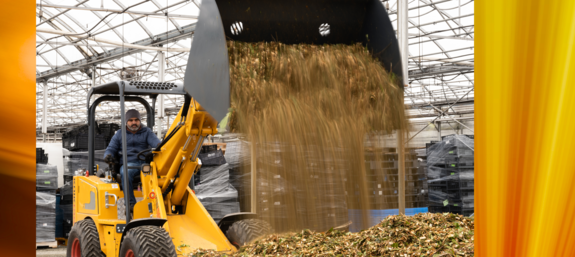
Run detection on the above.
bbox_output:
[226,219,273,248]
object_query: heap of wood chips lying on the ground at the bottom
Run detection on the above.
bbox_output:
[190,213,475,257]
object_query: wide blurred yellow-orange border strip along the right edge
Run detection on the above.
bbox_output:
[475,0,575,257]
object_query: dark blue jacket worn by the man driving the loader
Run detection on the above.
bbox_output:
[104,125,160,163]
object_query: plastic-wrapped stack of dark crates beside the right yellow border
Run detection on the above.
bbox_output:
[427,135,474,216]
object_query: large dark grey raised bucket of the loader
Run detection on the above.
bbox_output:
[184,0,403,121]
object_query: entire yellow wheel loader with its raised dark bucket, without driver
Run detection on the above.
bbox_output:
[67,0,402,254]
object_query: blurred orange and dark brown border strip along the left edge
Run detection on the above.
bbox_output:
[0,0,36,256]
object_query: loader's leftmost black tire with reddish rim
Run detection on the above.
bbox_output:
[66,219,106,257]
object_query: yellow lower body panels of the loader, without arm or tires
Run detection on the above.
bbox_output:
[73,169,236,256]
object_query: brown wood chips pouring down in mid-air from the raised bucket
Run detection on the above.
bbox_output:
[228,41,407,232]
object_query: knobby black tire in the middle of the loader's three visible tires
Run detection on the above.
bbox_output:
[120,226,177,257]
